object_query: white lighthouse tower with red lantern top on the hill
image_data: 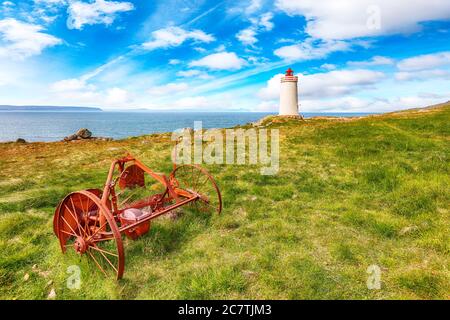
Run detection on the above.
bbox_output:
[280,68,299,117]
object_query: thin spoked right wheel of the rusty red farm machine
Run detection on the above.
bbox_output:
[170,164,222,213]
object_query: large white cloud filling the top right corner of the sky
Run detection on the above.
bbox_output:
[276,0,450,40]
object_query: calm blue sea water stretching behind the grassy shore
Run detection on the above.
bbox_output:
[0,112,372,142]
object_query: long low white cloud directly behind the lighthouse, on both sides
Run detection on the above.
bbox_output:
[258,69,384,100]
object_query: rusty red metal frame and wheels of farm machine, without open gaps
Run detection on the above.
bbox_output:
[53,155,222,279]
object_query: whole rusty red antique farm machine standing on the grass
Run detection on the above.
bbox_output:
[53,155,222,279]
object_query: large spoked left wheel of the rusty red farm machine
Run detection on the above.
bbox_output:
[53,191,125,279]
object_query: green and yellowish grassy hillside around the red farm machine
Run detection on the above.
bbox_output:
[0,104,450,299]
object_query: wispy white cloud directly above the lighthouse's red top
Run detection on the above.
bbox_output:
[274,38,351,61]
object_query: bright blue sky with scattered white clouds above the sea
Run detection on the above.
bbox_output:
[0,0,450,112]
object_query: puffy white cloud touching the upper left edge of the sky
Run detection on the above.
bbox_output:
[0,18,62,59]
